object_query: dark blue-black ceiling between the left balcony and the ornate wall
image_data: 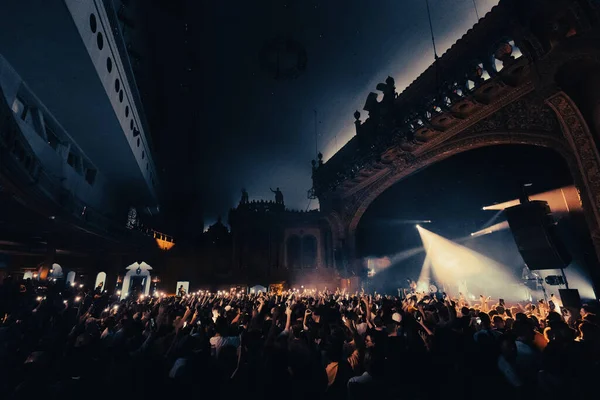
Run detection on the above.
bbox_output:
[135,0,497,238]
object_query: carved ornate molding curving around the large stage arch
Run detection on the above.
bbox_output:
[330,92,600,268]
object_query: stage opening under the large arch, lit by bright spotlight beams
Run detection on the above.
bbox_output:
[359,146,596,302]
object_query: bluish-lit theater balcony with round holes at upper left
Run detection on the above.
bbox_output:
[0,0,159,247]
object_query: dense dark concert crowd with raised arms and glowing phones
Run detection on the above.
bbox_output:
[0,278,600,400]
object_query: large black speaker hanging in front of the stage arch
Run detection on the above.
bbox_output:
[504,200,572,270]
